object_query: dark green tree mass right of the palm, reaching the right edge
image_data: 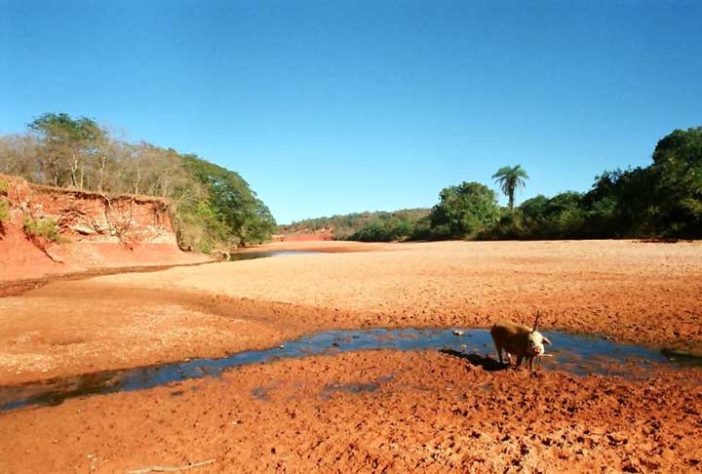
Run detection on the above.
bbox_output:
[478,127,702,239]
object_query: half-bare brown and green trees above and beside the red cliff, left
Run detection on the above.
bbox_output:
[0,113,276,253]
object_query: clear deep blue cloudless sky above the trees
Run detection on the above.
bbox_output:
[0,0,702,223]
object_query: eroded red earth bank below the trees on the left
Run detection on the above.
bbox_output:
[0,175,206,282]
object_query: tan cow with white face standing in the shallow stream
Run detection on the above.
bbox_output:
[490,312,551,369]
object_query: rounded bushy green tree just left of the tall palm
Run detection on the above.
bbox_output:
[430,182,500,237]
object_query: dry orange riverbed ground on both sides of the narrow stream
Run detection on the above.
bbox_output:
[0,241,702,473]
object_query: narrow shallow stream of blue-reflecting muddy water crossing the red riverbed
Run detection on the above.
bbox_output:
[0,329,702,411]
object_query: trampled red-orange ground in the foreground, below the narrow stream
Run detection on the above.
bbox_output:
[0,351,702,473]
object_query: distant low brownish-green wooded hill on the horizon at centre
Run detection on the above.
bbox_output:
[278,209,431,242]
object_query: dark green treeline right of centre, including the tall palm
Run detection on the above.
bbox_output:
[292,127,702,241]
